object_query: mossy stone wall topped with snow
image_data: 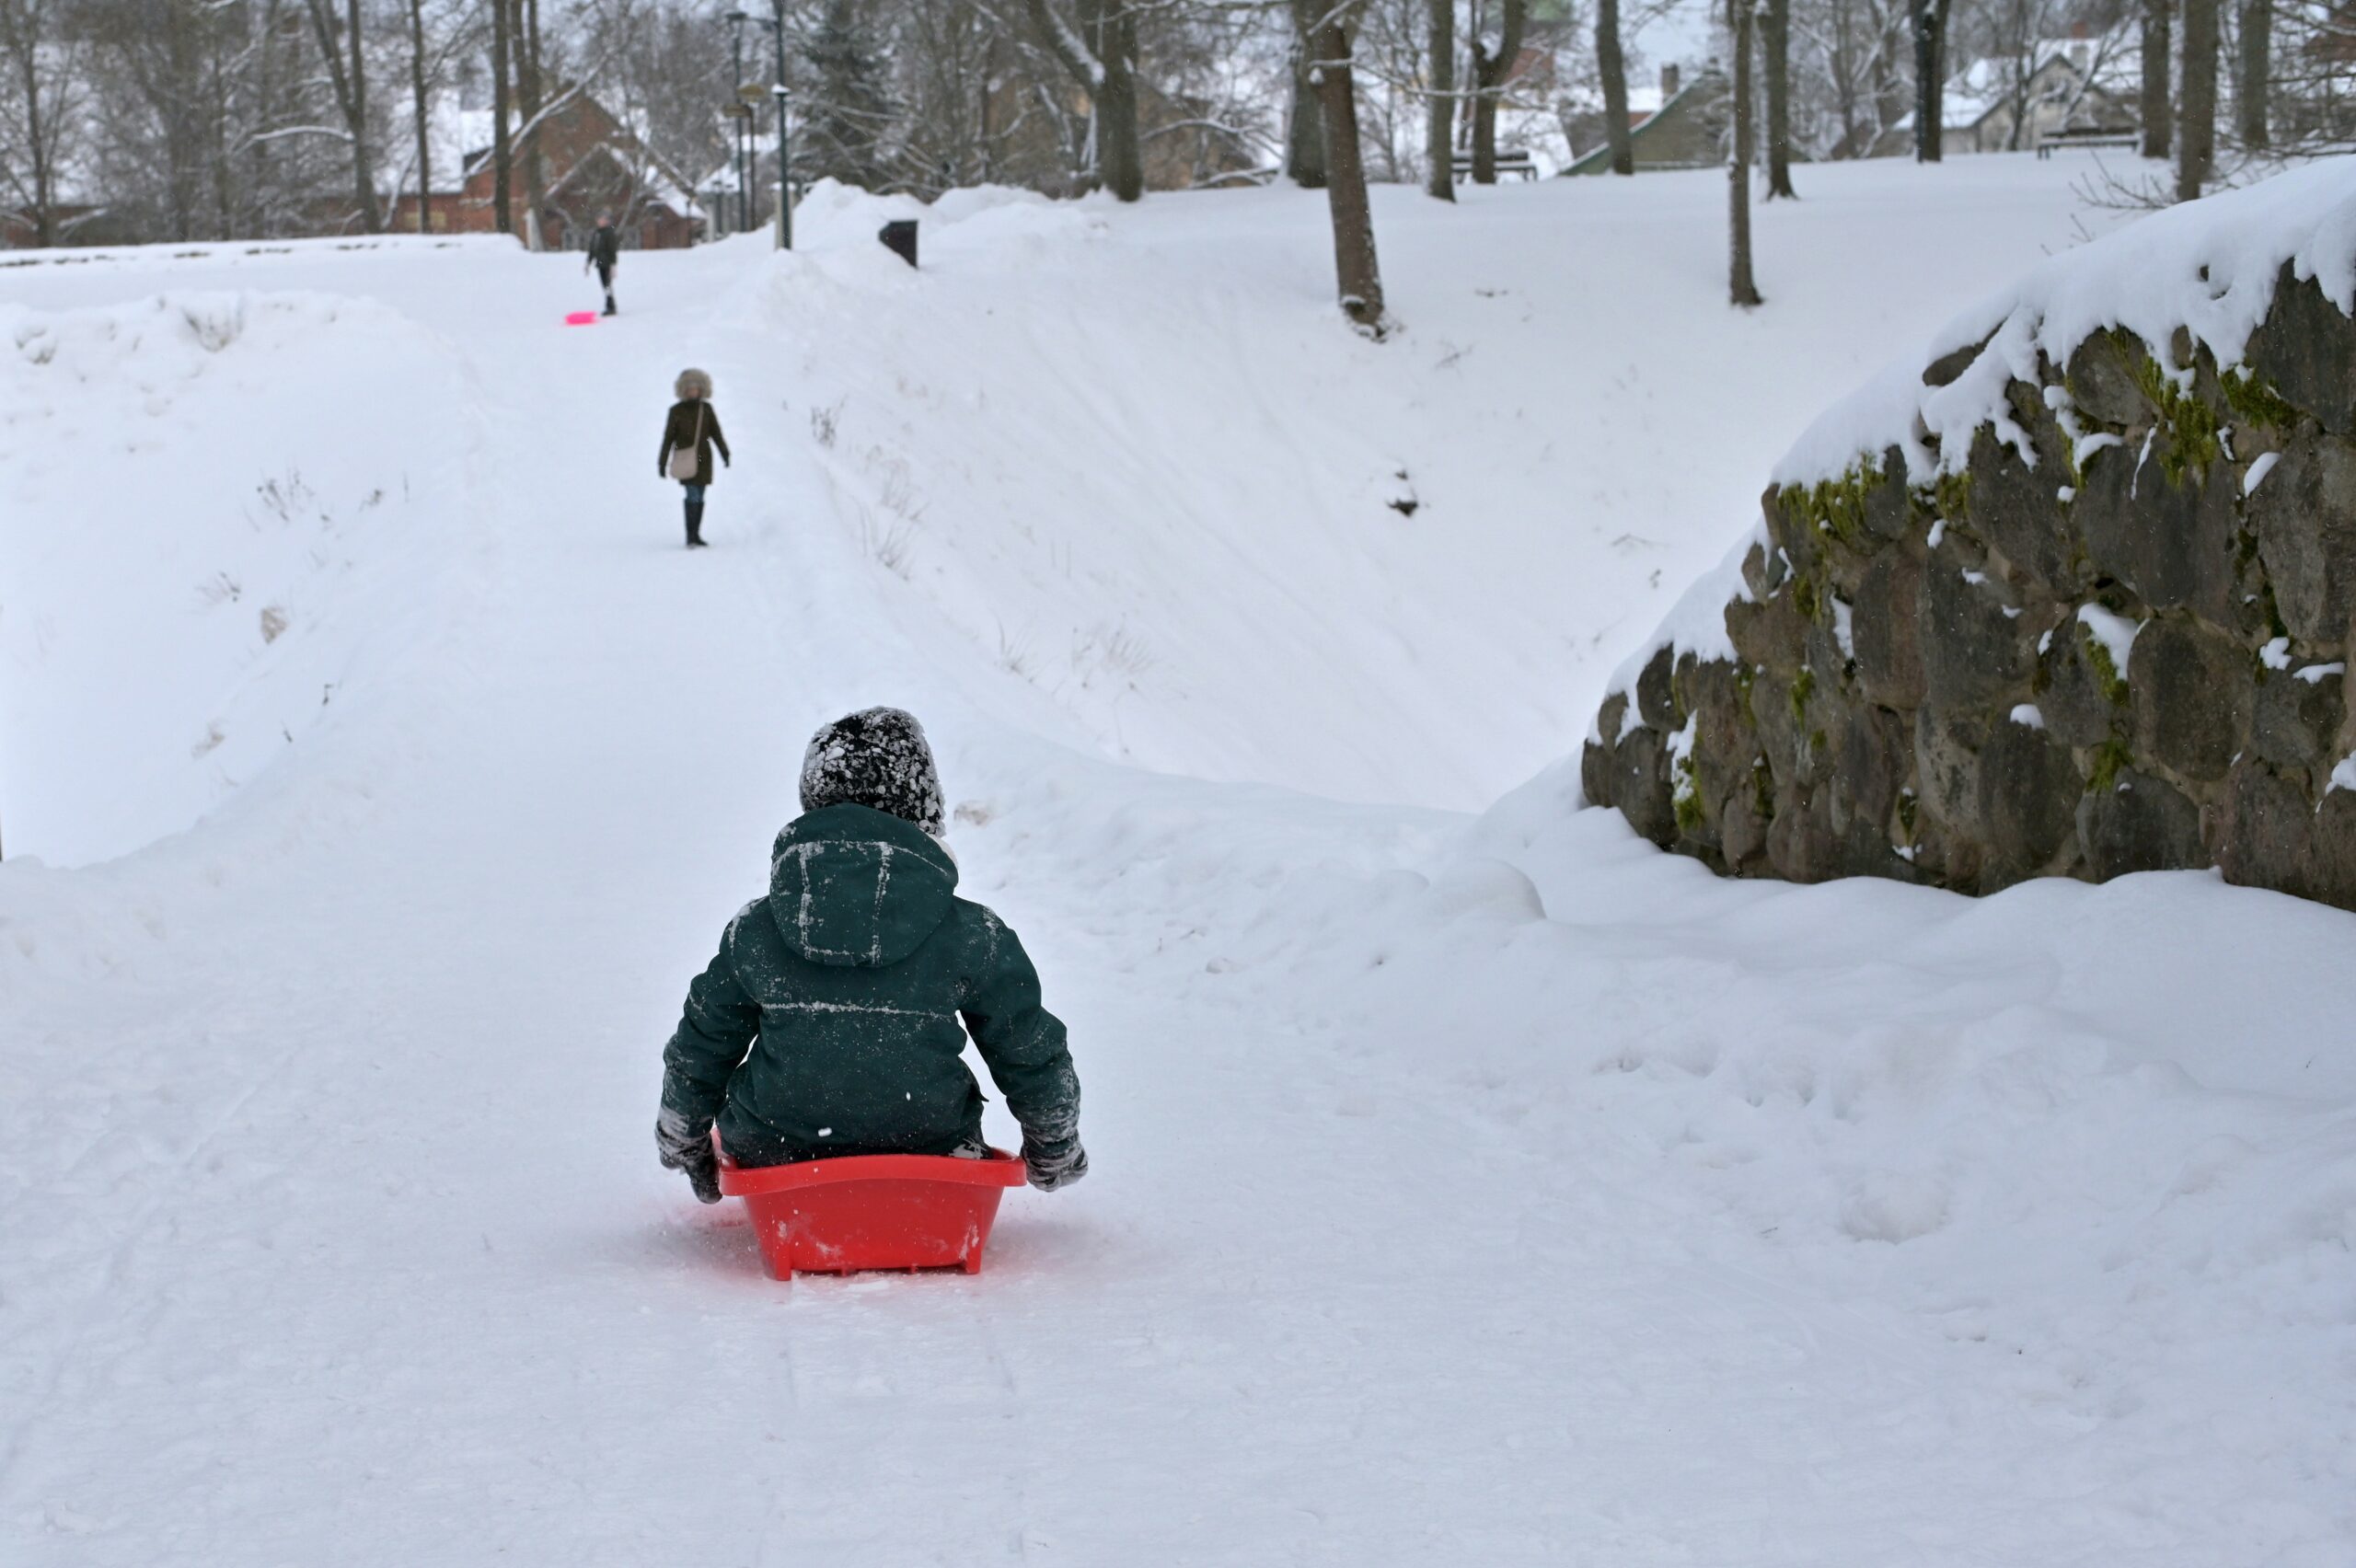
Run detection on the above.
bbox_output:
[1581,157,2356,909]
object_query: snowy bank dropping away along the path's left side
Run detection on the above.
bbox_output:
[0,287,480,864]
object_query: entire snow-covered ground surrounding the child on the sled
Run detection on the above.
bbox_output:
[0,157,2356,1568]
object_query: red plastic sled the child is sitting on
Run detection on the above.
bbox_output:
[721,1149,1022,1278]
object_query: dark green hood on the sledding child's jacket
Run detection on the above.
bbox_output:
[768,802,956,970]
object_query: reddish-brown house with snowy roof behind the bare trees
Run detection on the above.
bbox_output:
[384,92,704,249]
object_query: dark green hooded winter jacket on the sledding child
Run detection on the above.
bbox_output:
[662,805,1079,1165]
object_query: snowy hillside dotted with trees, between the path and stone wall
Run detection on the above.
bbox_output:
[723,163,2148,808]
